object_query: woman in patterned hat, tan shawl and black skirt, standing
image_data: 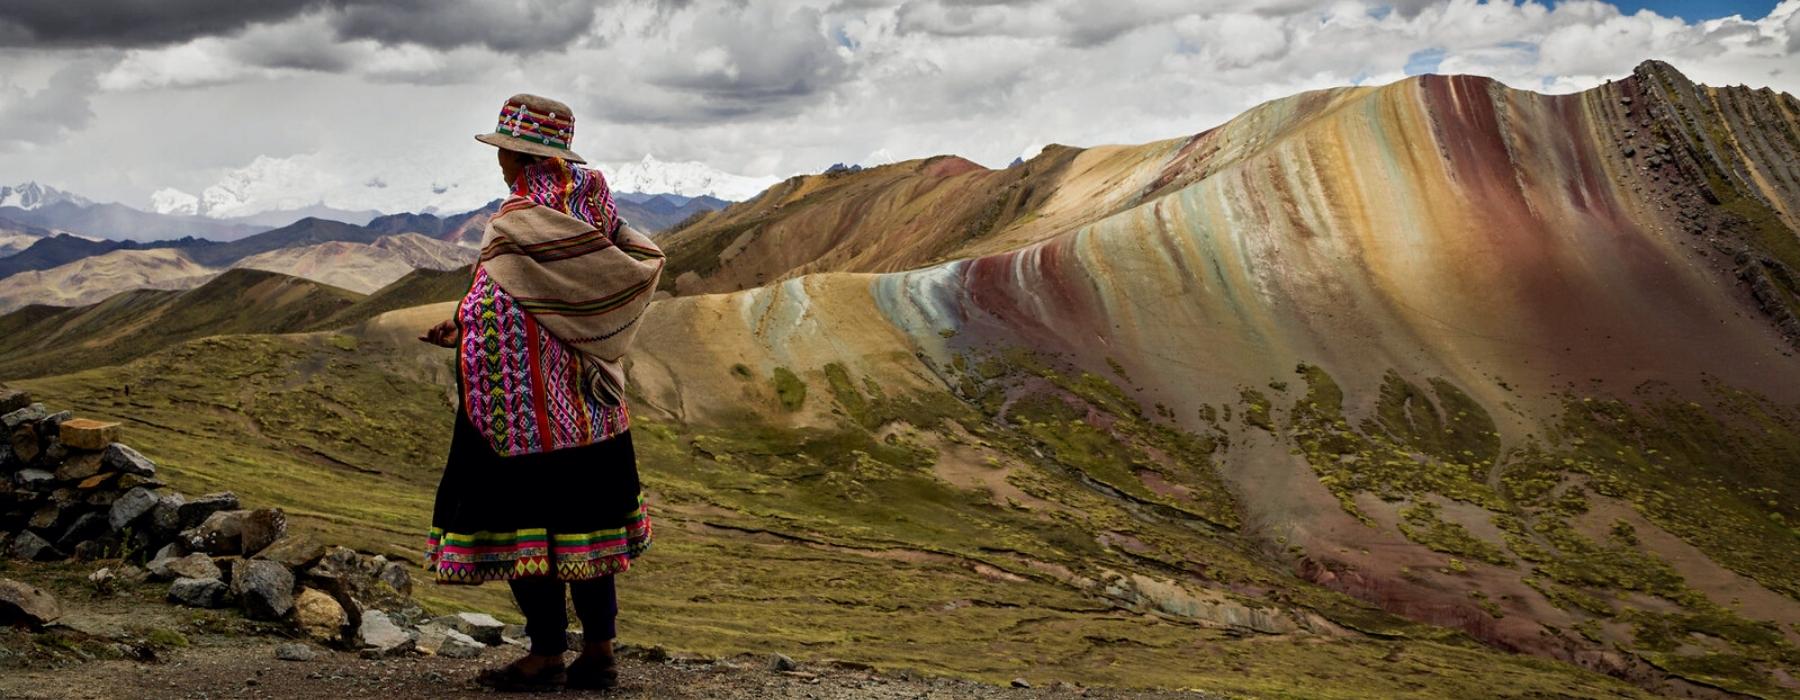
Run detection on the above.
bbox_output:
[421,95,662,689]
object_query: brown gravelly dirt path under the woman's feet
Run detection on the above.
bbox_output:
[0,639,1202,700]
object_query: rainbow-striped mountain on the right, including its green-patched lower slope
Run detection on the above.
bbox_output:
[842,63,1800,693]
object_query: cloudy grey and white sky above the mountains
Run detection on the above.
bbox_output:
[0,0,1800,212]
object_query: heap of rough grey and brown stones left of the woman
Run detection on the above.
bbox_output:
[0,387,524,657]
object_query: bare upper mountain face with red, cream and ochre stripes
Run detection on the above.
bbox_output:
[875,65,1800,408]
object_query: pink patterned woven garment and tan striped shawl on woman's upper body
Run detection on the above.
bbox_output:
[457,158,664,457]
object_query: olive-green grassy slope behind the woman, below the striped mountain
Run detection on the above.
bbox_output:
[22,333,1634,696]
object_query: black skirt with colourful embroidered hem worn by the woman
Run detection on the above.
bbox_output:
[425,410,650,583]
